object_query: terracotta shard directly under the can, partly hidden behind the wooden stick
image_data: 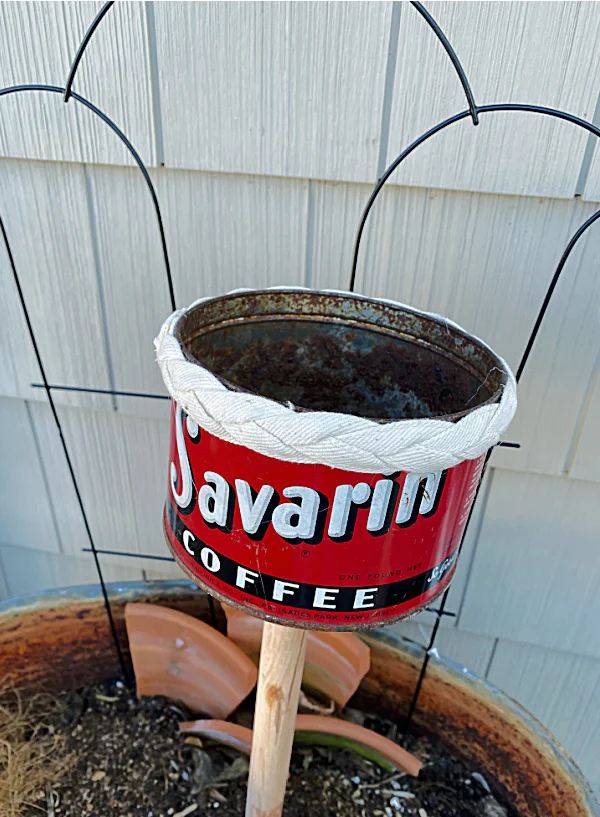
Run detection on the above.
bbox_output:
[222,604,371,708]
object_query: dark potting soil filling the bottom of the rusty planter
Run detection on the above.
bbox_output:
[27,682,518,817]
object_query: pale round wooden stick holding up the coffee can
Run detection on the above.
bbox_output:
[246,622,306,817]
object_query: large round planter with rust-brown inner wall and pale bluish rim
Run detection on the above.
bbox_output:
[0,582,600,817]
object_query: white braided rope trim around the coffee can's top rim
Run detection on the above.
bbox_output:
[154,287,517,474]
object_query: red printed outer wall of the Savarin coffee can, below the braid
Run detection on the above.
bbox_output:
[164,405,483,630]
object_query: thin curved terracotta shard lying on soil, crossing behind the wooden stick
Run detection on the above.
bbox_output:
[179,715,422,777]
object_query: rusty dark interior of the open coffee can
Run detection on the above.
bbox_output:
[175,290,506,422]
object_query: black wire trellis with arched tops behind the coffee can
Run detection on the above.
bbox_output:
[0,2,600,731]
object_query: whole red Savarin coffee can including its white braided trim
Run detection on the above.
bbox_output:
[156,289,516,630]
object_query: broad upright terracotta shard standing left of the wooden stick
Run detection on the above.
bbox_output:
[125,603,257,718]
